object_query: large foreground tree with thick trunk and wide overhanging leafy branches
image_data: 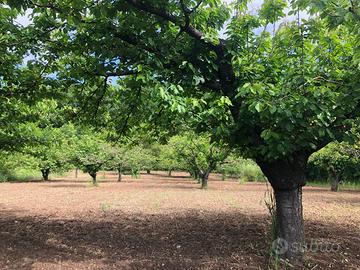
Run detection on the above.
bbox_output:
[5,0,360,263]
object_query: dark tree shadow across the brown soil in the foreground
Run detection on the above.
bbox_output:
[0,211,360,269]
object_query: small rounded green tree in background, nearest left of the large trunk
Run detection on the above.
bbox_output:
[168,133,229,189]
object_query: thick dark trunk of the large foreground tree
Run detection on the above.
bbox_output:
[258,154,308,266]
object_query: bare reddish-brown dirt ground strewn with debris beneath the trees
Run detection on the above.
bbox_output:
[0,172,360,270]
